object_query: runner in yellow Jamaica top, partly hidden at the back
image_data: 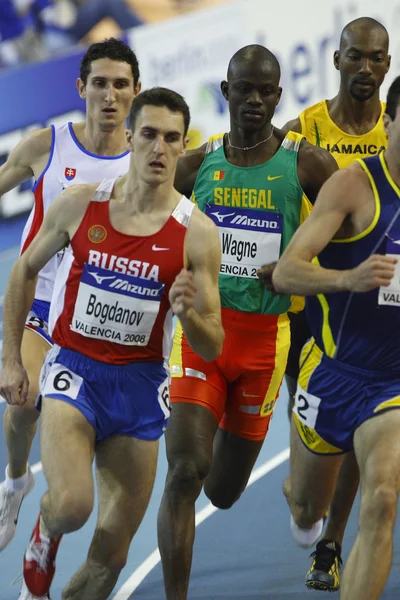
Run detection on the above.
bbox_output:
[285,17,390,591]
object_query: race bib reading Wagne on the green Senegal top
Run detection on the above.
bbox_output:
[206,205,282,279]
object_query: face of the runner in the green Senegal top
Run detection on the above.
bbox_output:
[221,60,282,133]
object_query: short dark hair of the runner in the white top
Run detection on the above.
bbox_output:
[80,38,140,87]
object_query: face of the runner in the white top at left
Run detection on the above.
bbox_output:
[77,58,140,130]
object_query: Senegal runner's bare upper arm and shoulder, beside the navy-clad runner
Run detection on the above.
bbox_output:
[297,140,338,204]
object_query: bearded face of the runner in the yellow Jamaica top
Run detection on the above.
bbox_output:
[334,28,390,102]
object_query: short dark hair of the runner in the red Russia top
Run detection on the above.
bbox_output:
[129,87,190,135]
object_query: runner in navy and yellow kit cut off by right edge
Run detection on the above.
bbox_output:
[272,77,400,600]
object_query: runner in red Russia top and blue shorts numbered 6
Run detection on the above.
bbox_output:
[0,88,224,600]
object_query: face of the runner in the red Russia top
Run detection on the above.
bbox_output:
[128,104,188,185]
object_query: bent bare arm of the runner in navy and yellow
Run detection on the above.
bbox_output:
[272,167,396,296]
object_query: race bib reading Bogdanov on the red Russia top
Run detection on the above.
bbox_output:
[71,264,164,346]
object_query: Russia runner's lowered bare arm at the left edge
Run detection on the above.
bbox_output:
[0,186,92,404]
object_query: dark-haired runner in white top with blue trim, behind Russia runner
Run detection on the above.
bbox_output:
[0,39,140,550]
